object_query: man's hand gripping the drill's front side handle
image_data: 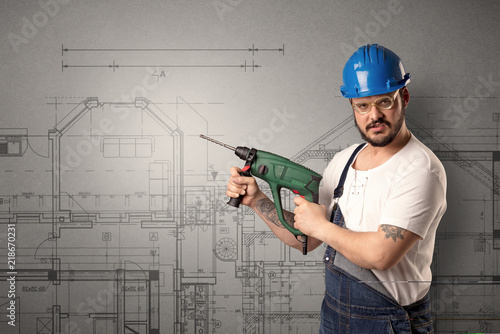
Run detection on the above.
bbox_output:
[226,167,267,207]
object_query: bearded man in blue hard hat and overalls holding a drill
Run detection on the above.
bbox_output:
[227,44,446,333]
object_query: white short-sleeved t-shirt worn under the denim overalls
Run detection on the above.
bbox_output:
[319,135,446,306]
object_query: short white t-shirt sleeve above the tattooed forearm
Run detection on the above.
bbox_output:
[380,168,446,238]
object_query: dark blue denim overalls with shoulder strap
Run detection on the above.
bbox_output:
[319,144,434,334]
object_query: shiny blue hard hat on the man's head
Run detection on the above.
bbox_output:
[340,44,410,98]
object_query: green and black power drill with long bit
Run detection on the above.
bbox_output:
[200,135,322,255]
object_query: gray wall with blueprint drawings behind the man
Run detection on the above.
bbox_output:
[0,0,500,334]
